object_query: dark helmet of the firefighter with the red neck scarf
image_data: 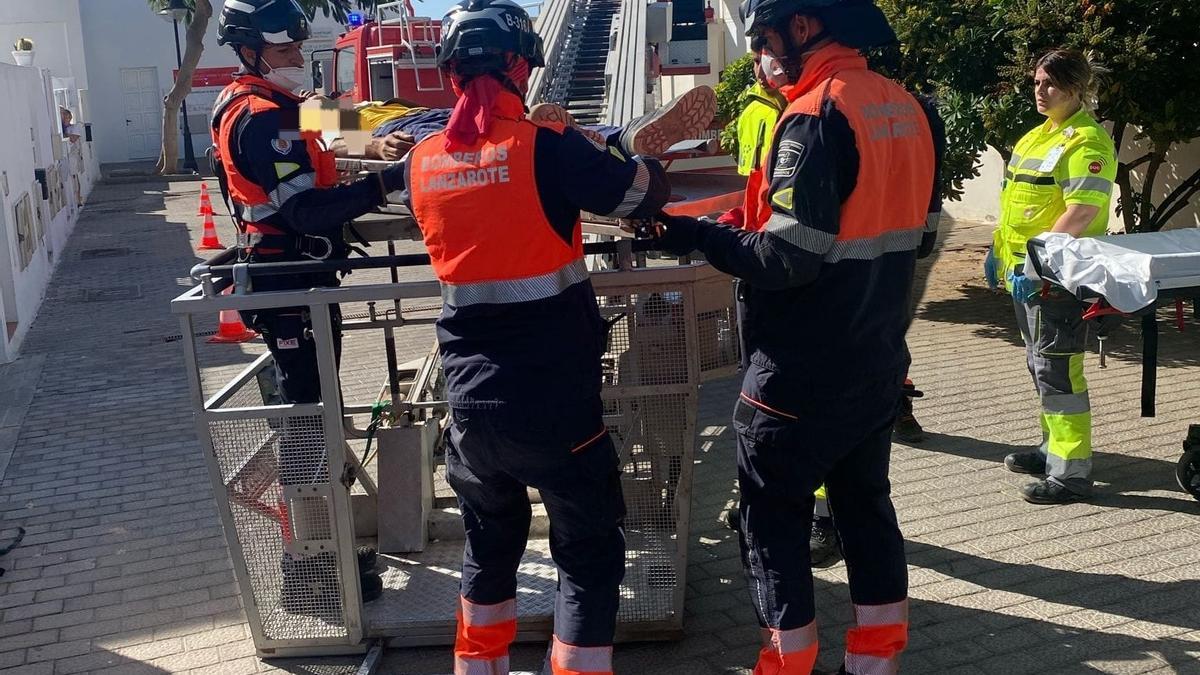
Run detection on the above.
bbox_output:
[437,0,546,71]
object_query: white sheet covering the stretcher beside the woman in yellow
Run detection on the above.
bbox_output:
[1025,228,1200,312]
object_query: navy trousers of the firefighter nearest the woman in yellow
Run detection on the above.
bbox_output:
[733,362,908,631]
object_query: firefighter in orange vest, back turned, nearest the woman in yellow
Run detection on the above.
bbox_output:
[661,0,937,675]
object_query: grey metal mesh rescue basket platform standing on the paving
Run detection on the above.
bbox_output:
[173,249,737,657]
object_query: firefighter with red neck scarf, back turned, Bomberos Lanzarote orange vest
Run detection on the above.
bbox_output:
[408,0,670,674]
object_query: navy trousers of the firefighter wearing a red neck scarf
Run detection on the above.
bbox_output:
[446,398,625,646]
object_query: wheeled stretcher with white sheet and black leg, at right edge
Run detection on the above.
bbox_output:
[1025,229,1200,500]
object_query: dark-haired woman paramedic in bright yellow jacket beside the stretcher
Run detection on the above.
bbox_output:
[984,49,1117,504]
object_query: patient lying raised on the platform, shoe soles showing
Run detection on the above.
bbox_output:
[334,85,716,161]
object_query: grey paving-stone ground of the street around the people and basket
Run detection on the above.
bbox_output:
[0,184,1200,675]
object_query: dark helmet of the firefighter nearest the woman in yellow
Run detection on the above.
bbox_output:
[738,0,896,49]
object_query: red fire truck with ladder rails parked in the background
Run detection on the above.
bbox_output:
[311,1,455,108]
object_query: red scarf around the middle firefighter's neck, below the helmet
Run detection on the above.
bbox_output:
[445,59,529,150]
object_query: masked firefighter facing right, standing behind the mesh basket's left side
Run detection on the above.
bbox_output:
[210,0,403,612]
